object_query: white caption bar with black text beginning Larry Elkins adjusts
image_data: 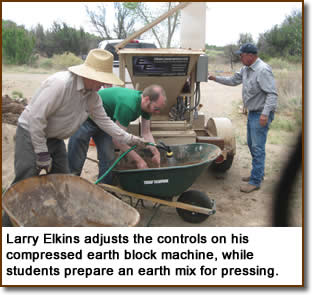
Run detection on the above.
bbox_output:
[2,227,303,286]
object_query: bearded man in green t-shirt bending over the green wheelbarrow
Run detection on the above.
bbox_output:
[68,85,166,184]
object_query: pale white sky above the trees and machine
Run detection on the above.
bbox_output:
[2,2,302,46]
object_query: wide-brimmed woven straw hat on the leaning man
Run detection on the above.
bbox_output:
[68,49,124,85]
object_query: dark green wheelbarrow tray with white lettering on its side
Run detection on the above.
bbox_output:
[114,143,221,199]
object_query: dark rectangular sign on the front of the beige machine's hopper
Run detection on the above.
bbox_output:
[132,56,190,76]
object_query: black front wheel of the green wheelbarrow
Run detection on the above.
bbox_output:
[176,190,213,223]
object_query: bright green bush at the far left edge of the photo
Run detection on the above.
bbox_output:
[2,21,35,65]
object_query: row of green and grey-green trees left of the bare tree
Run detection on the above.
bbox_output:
[2,21,100,63]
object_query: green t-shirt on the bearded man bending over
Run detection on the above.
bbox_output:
[98,87,151,127]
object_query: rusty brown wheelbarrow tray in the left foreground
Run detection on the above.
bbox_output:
[2,174,140,227]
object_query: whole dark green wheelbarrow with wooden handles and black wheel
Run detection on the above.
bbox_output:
[98,143,221,225]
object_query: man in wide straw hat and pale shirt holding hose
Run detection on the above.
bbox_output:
[13,49,145,183]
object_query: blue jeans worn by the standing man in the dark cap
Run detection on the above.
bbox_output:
[247,112,274,187]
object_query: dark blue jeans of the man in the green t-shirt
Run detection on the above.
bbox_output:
[68,119,115,184]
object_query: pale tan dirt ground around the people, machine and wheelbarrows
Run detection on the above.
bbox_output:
[2,72,302,227]
